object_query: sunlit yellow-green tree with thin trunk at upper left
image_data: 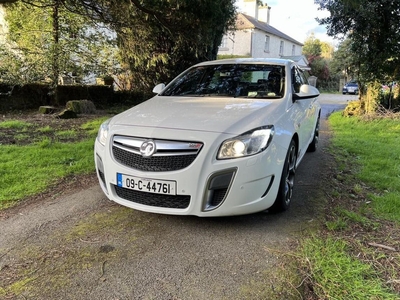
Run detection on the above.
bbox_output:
[0,0,117,85]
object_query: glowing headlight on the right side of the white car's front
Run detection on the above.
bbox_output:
[217,125,274,159]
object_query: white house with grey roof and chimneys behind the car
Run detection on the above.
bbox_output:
[218,0,309,70]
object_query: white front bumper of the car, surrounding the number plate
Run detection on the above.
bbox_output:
[95,127,286,217]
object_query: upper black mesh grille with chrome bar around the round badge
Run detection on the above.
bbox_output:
[112,136,203,172]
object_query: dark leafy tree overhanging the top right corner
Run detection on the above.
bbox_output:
[315,0,400,81]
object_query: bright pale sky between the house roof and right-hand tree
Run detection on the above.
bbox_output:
[236,0,338,46]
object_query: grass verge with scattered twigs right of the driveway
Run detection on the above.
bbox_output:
[298,113,400,300]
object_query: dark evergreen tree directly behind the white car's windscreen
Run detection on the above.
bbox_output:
[65,0,236,90]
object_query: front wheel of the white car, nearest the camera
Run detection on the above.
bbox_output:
[269,140,297,213]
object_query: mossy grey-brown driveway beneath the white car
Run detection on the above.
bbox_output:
[0,95,356,300]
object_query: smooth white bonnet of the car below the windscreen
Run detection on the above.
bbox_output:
[111,96,282,134]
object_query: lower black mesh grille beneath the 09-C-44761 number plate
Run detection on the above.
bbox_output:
[114,185,190,209]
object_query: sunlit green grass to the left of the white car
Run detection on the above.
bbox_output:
[0,118,106,209]
